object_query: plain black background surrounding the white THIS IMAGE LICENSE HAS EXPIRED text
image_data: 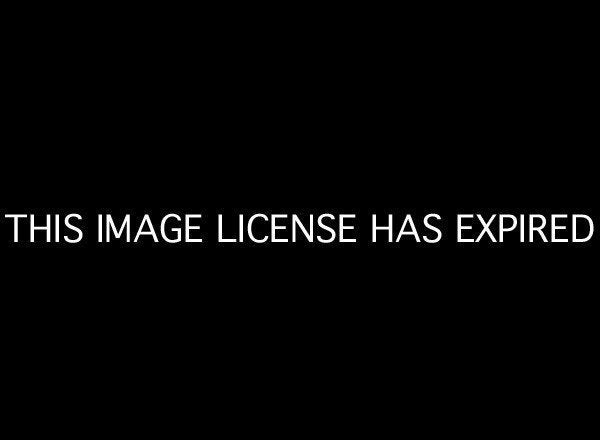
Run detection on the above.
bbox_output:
[1,5,598,433]
